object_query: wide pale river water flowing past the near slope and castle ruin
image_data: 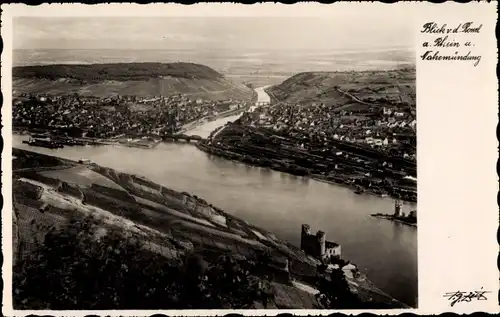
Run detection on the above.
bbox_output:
[13,127,417,306]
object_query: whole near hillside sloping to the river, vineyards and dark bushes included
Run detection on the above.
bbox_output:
[13,148,404,309]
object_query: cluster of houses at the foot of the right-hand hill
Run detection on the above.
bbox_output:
[245,103,417,160]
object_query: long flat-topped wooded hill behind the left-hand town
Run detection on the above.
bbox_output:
[12,63,254,100]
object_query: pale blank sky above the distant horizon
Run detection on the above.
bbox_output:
[13,6,416,50]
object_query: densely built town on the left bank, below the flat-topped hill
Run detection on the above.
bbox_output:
[12,94,248,138]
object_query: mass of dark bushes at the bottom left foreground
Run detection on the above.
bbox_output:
[13,218,264,310]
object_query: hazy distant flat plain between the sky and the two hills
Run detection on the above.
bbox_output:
[13,47,415,87]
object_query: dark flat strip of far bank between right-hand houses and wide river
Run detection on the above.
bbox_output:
[197,122,417,202]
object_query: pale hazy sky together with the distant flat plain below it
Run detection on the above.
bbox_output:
[13,13,415,76]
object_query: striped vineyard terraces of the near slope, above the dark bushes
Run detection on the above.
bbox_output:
[13,149,406,308]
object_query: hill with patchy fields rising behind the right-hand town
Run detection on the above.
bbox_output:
[266,69,415,111]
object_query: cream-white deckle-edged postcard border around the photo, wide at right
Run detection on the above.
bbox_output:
[1,2,499,316]
